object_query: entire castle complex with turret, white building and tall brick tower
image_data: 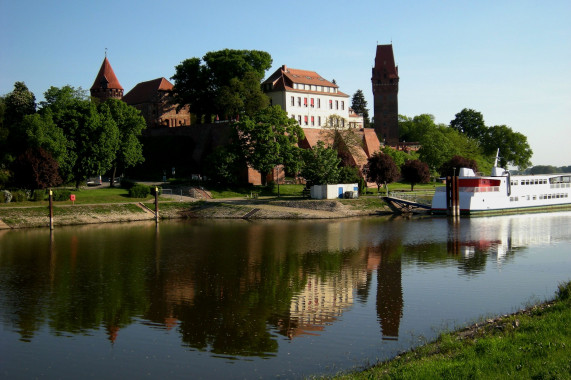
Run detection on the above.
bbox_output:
[90,45,399,185]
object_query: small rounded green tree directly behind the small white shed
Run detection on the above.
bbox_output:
[301,141,341,186]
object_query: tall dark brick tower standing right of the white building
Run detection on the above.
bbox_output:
[371,45,399,145]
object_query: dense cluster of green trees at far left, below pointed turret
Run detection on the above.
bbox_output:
[0,82,146,189]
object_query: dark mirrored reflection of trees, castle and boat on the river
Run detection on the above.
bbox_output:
[0,214,569,366]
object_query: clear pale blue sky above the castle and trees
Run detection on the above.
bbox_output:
[0,0,571,166]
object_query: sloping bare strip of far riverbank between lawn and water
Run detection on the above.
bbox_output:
[0,198,392,230]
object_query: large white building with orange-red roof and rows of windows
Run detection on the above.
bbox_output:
[262,65,354,128]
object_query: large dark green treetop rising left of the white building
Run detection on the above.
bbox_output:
[171,49,272,122]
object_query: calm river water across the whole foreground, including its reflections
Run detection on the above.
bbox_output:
[0,212,571,379]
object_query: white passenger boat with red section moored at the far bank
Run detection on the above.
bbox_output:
[431,157,571,215]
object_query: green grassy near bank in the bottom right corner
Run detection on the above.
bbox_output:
[328,282,571,379]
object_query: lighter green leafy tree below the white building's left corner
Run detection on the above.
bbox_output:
[234,106,304,184]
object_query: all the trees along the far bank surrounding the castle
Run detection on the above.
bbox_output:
[0,49,548,194]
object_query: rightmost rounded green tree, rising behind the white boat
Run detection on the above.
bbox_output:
[482,125,533,170]
